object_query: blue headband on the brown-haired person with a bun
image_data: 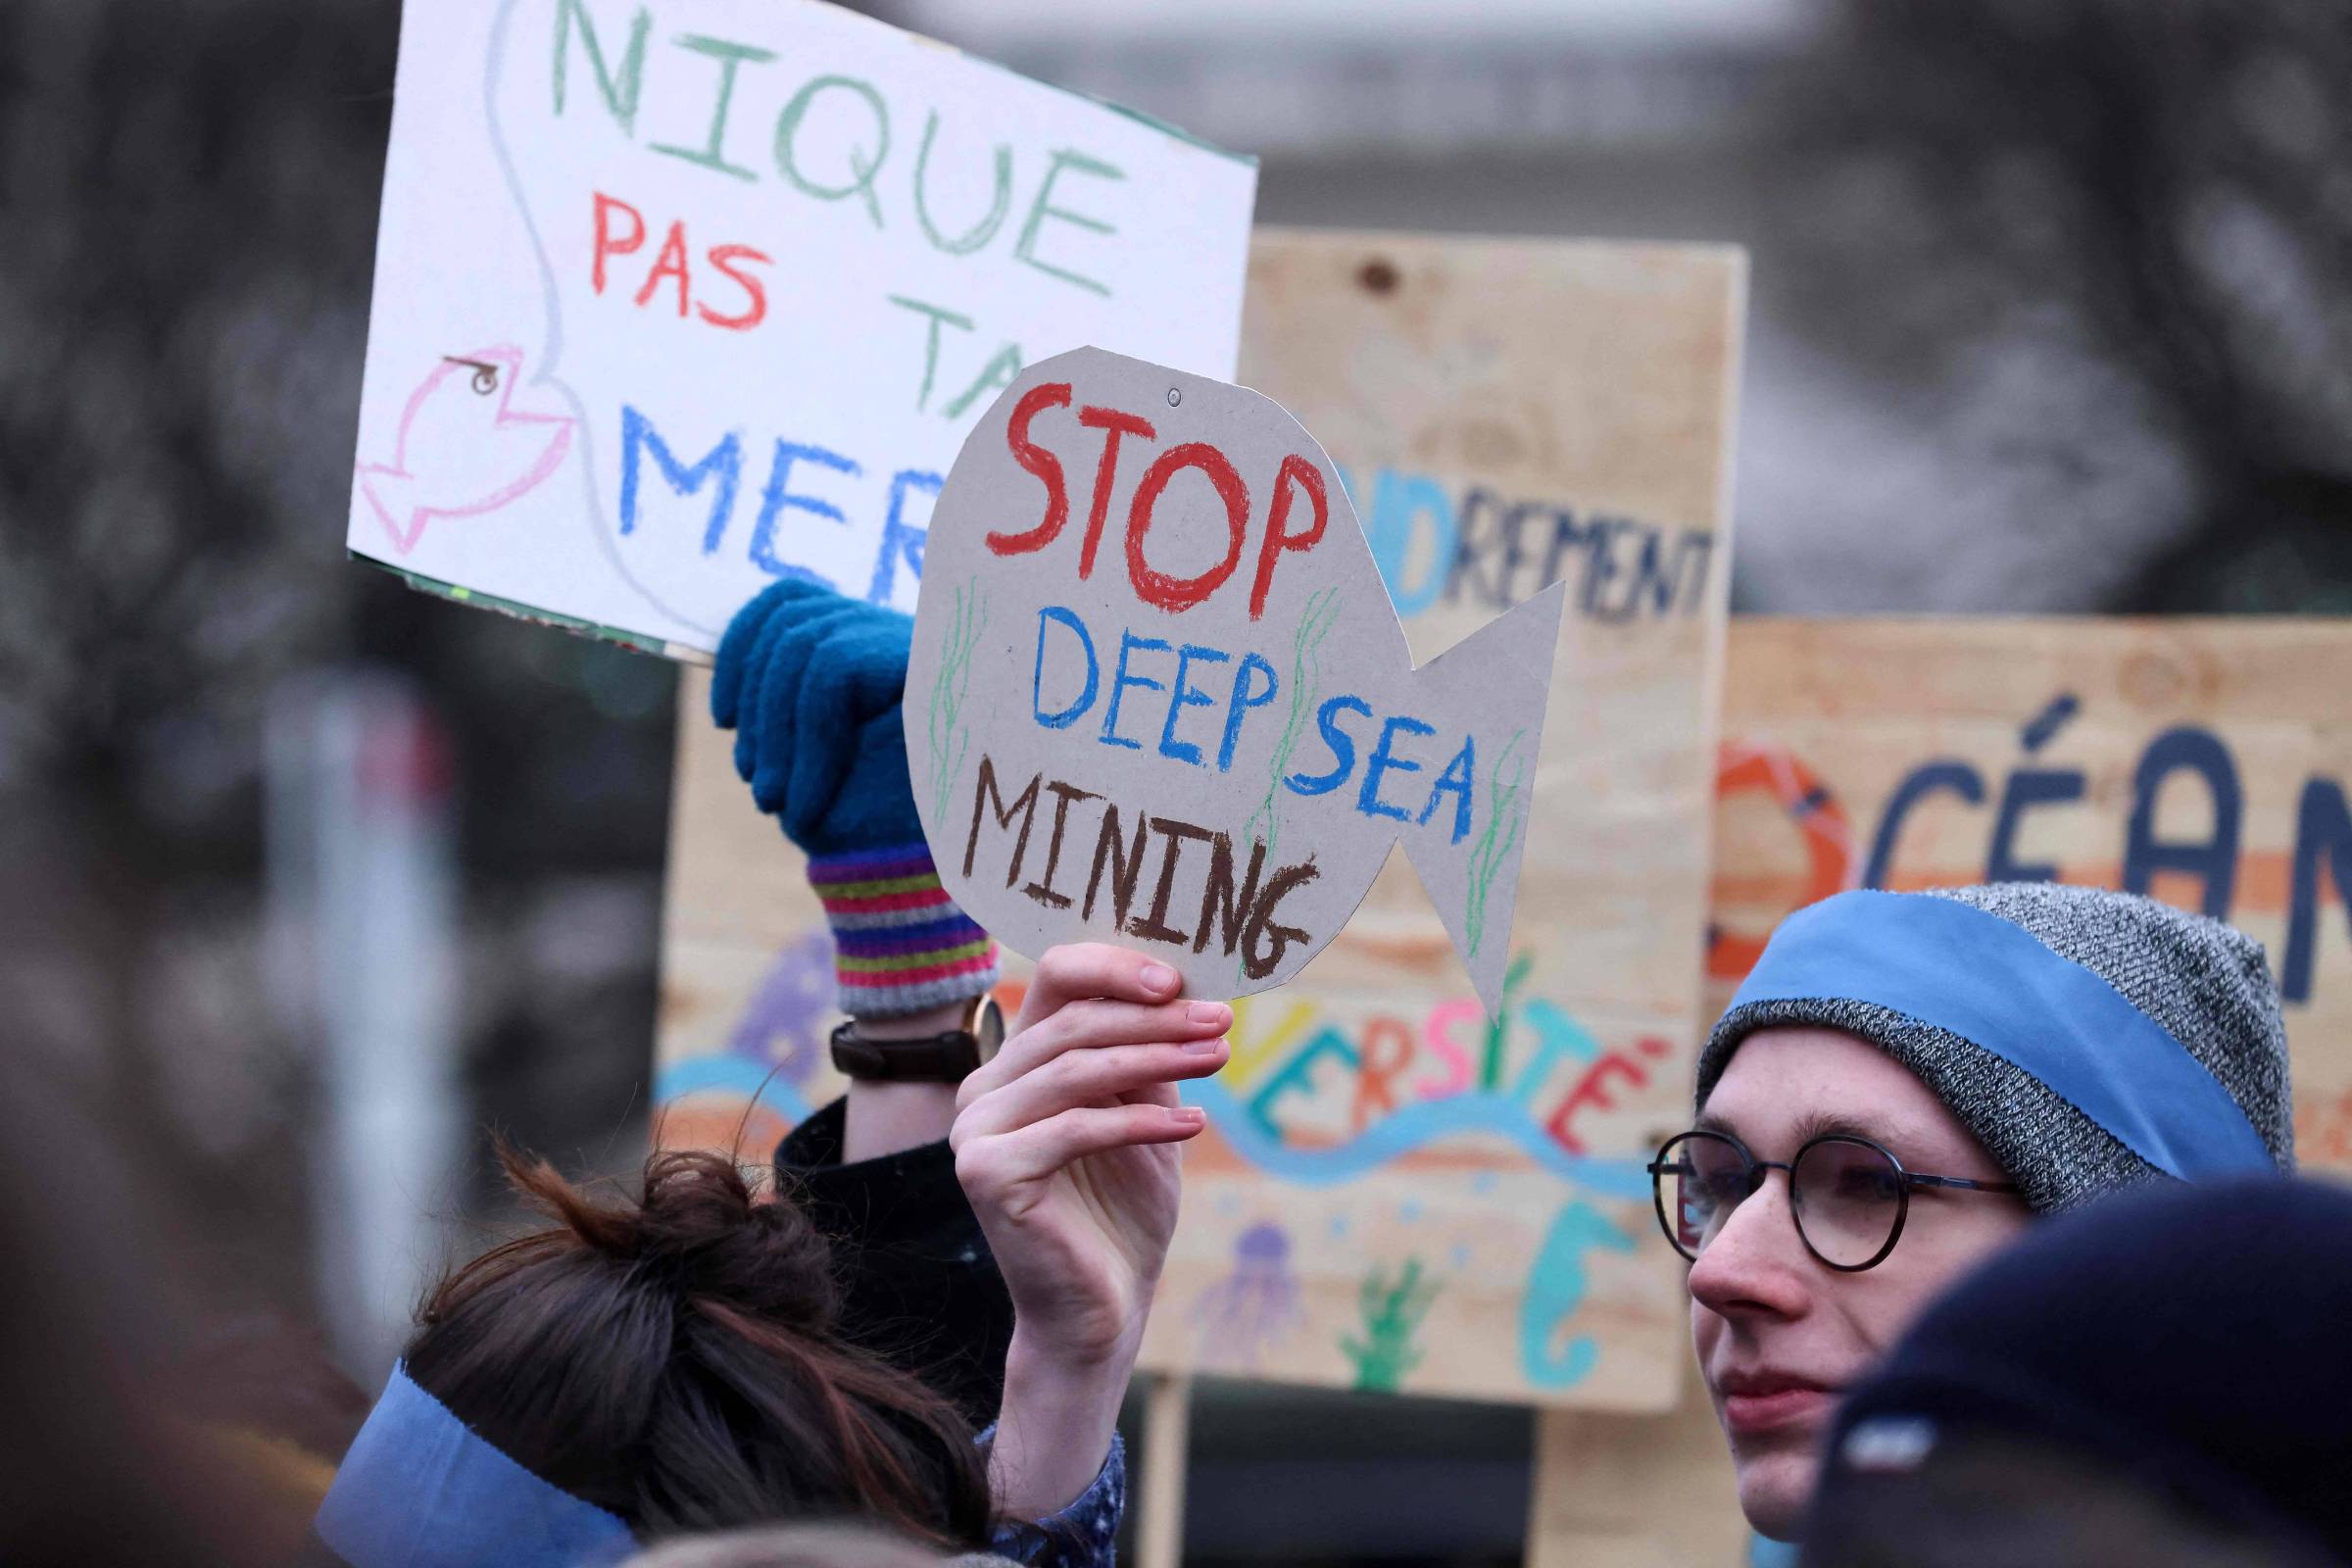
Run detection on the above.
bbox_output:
[316,1366,637,1568]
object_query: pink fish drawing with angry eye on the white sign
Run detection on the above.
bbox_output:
[358,346,574,555]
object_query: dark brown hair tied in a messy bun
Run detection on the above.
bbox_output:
[407,1145,990,1549]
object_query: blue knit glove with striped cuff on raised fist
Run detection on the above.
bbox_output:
[710,581,998,1018]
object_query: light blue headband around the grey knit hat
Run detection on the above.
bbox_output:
[1731,891,2277,1180]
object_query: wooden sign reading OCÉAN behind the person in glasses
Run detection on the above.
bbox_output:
[1529,618,2352,1568]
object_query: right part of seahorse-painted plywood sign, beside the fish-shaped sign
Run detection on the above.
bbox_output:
[1146,235,1742,1408]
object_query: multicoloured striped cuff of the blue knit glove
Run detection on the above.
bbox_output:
[809,844,998,1018]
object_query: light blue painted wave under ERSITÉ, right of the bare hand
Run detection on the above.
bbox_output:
[1183,1079,1648,1201]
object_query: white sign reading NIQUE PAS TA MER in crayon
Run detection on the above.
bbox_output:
[348,0,1256,651]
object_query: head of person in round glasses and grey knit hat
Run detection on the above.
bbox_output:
[1648,884,2293,1540]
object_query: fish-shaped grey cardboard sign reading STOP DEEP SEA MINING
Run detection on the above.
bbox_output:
[906,348,1564,1013]
